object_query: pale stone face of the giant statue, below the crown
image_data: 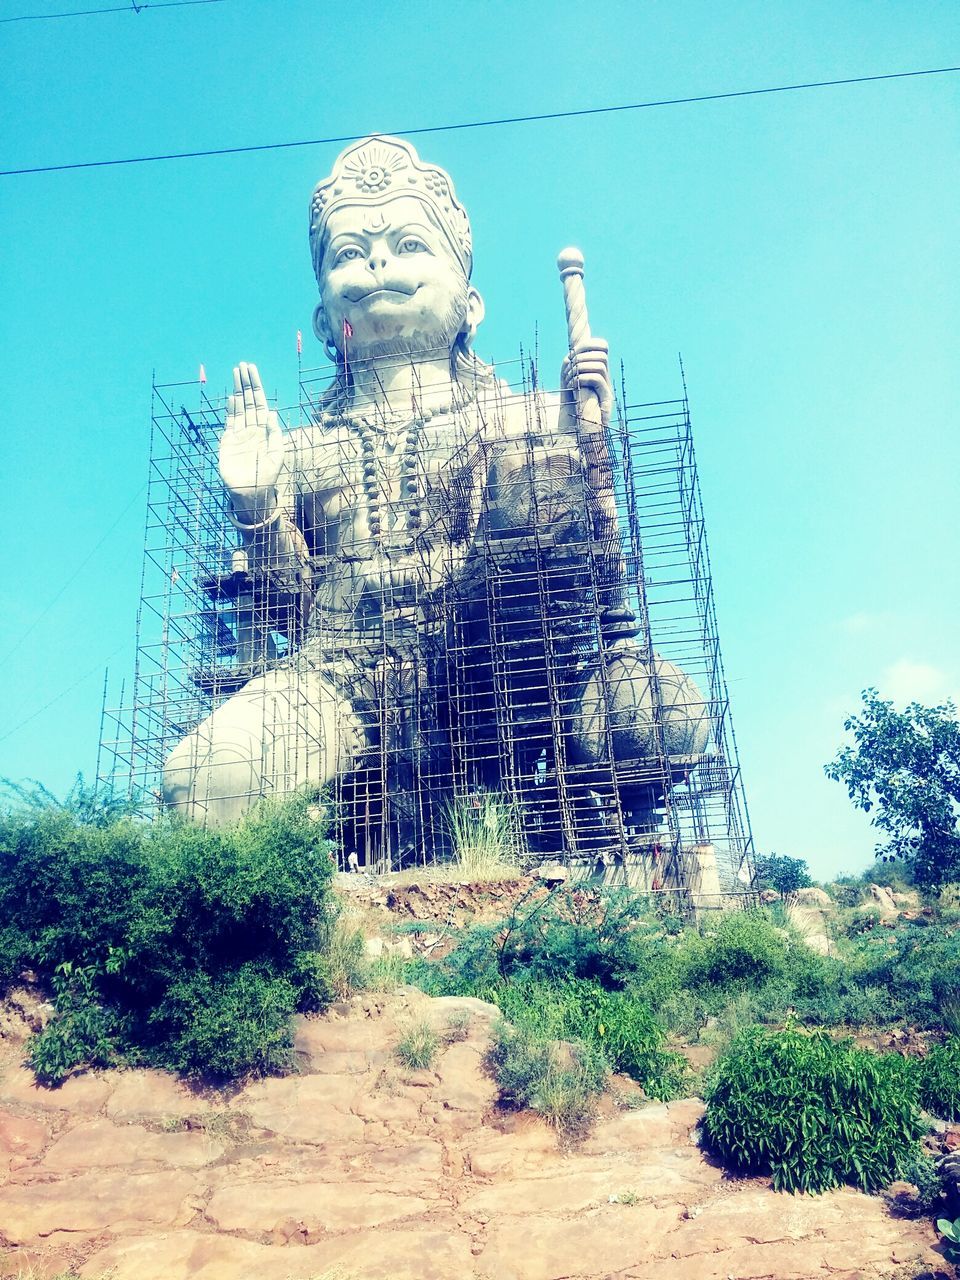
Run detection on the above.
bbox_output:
[317,196,474,355]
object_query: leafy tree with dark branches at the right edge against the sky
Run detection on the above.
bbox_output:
[824,689,960,888]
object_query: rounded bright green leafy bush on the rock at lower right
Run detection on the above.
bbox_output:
[704,1027,922,1192]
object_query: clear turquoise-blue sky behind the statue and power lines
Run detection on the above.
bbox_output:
[0,0,960,876]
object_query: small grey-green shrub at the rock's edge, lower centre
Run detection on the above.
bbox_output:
[489,1023,607,1140]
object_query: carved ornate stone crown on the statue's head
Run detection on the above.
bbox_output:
[310,134,474,279]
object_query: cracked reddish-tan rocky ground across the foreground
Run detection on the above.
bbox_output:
[0,988,945,1280]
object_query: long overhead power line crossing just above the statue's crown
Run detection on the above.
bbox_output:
[0,67,960,178]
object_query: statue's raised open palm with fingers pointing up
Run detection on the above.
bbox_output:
[220,364,283,522]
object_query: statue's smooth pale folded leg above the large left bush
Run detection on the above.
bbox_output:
[163,668,364,824]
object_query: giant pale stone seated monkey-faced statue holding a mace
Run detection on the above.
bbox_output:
[164,137,708,860]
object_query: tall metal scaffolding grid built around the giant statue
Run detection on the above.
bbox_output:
[99,357,753,892]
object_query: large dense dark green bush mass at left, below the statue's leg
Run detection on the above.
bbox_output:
[0,796,342,1083]
